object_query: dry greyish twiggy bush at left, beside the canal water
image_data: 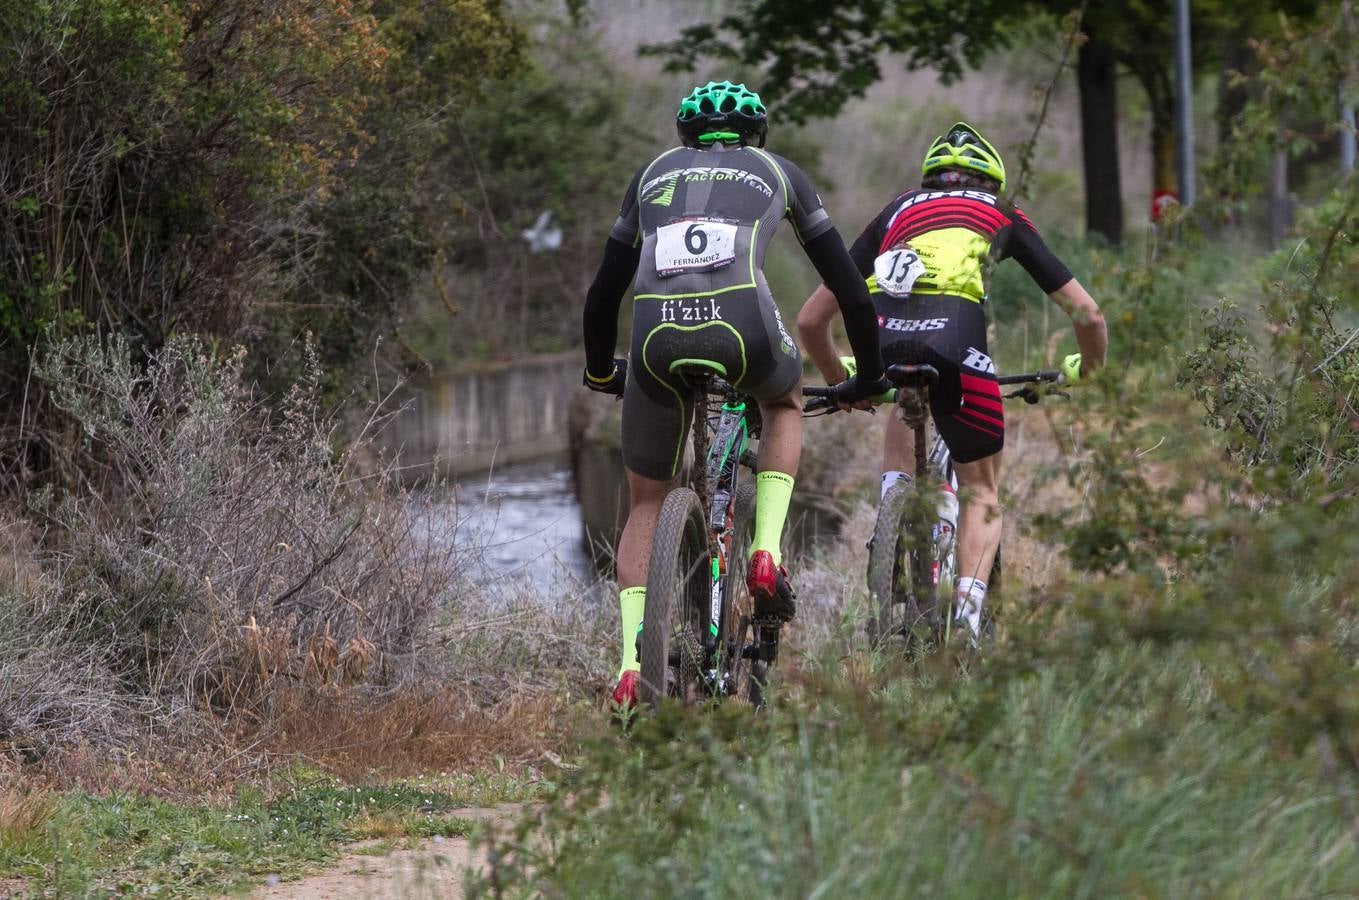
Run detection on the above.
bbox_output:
[7,339,462,737]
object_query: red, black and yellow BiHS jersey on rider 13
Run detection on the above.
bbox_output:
[849,188,1071,303]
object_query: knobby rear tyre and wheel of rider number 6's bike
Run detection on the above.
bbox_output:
[639,488,711,707]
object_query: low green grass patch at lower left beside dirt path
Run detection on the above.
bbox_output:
[0,769,548,896]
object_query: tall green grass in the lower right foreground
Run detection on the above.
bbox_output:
[475,644,1359,897]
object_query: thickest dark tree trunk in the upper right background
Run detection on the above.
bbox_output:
[1076,29,1123,243]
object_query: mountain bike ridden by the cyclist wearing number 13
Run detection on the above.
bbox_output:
[802,363,1064,647]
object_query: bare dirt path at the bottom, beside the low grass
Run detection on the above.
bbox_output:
[250,803,523,900]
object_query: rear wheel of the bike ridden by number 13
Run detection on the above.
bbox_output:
[868,484,936,647]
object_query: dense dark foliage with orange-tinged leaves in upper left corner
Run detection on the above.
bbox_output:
[0,0,522,486]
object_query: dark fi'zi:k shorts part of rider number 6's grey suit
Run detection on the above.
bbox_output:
[622,285,802,481]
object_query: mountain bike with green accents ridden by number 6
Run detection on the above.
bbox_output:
[639,360,781,707]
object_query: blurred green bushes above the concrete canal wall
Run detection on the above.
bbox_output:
[409,22,665,364]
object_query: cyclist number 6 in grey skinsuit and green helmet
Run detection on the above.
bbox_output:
[584,82,886,704]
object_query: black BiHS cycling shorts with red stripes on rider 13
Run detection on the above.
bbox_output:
[872,292,1006,462]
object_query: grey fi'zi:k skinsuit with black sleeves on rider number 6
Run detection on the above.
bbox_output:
[586,144,877,480]
